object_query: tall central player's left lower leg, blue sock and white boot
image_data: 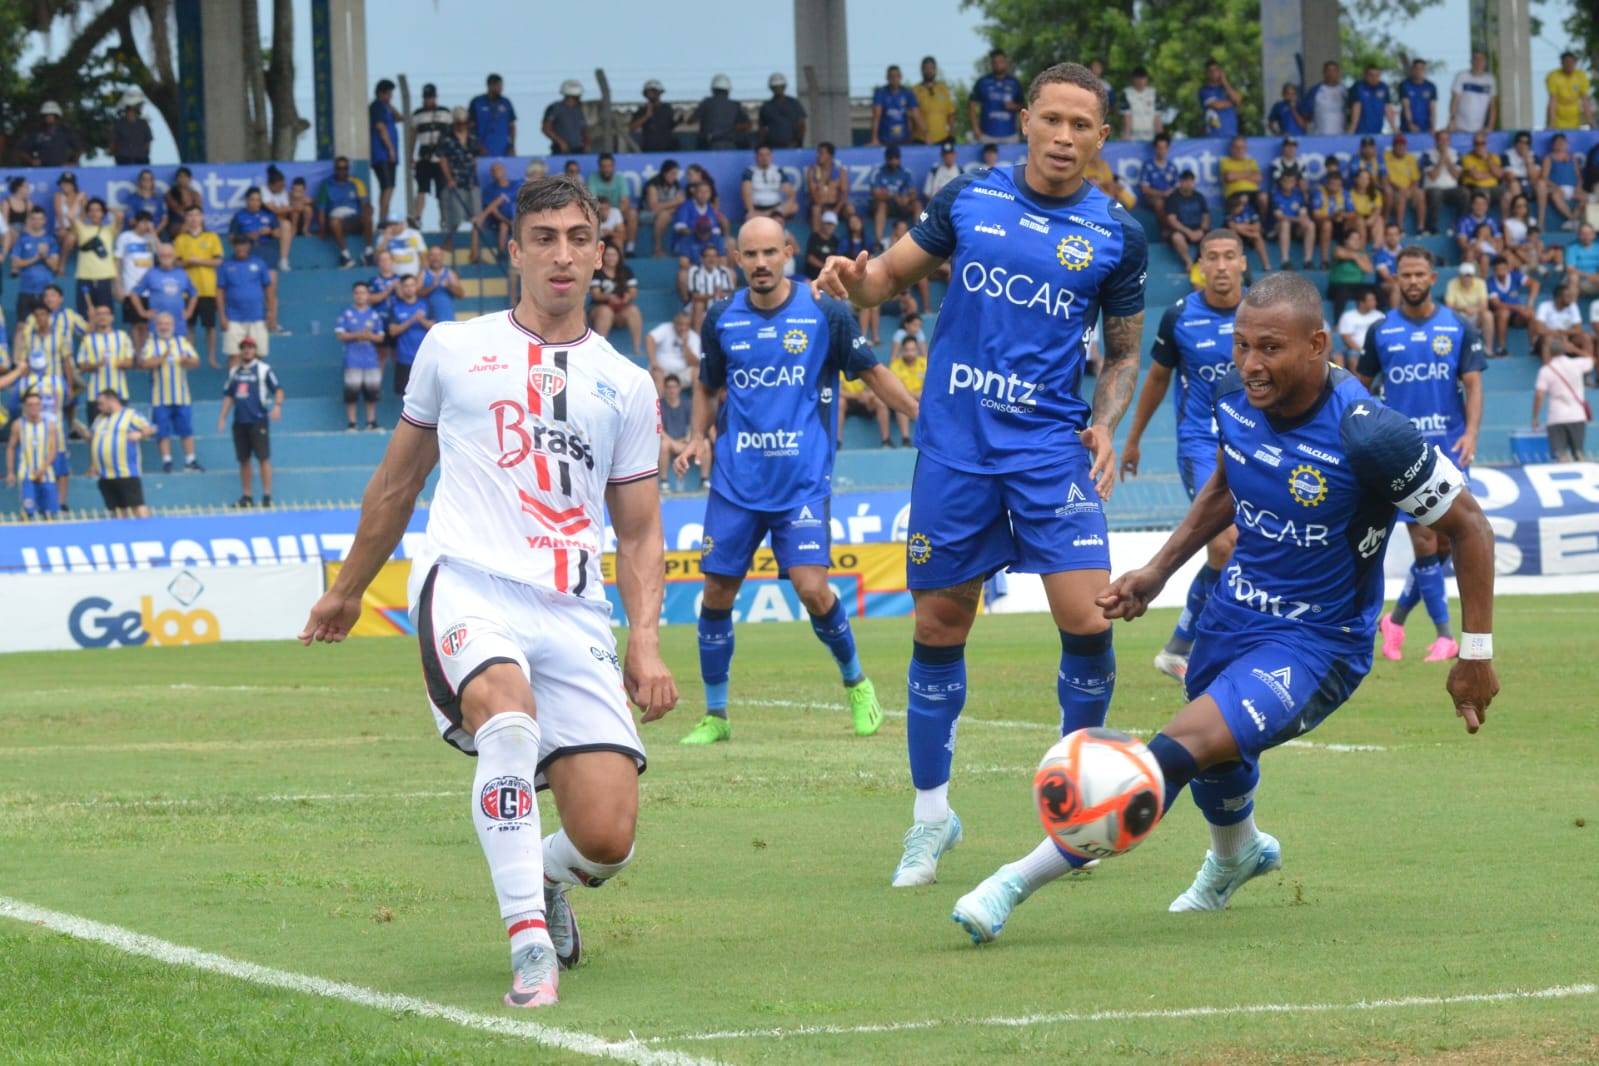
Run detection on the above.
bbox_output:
[892,641,966,889]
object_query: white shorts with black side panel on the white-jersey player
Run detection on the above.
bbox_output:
[411,559,644,788]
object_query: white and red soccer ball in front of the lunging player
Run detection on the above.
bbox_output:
[1033,729,1166,858]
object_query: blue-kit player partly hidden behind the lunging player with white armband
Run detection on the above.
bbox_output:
[1121,229,1249,681]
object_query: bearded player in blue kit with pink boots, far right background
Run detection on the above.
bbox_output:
[1354,246,1487,663]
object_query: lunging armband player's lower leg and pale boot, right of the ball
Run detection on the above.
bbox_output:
[1167,761,1282,914]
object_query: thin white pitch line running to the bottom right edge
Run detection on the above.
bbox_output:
[644,984,1599,1044]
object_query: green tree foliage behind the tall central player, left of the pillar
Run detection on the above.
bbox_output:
[963,0,1263,134]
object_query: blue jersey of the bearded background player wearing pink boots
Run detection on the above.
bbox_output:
[1356,307,1487,449]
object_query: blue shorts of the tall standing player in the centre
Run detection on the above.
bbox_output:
[905,452,1110,588]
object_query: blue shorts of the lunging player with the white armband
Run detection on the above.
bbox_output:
[1186,615,1366,764]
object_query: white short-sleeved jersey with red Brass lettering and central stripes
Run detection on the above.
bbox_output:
[401,312,660,606]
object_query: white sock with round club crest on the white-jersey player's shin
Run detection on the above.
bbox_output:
[472,711,550,956]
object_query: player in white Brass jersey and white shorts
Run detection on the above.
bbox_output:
[301,176,678,1007]
